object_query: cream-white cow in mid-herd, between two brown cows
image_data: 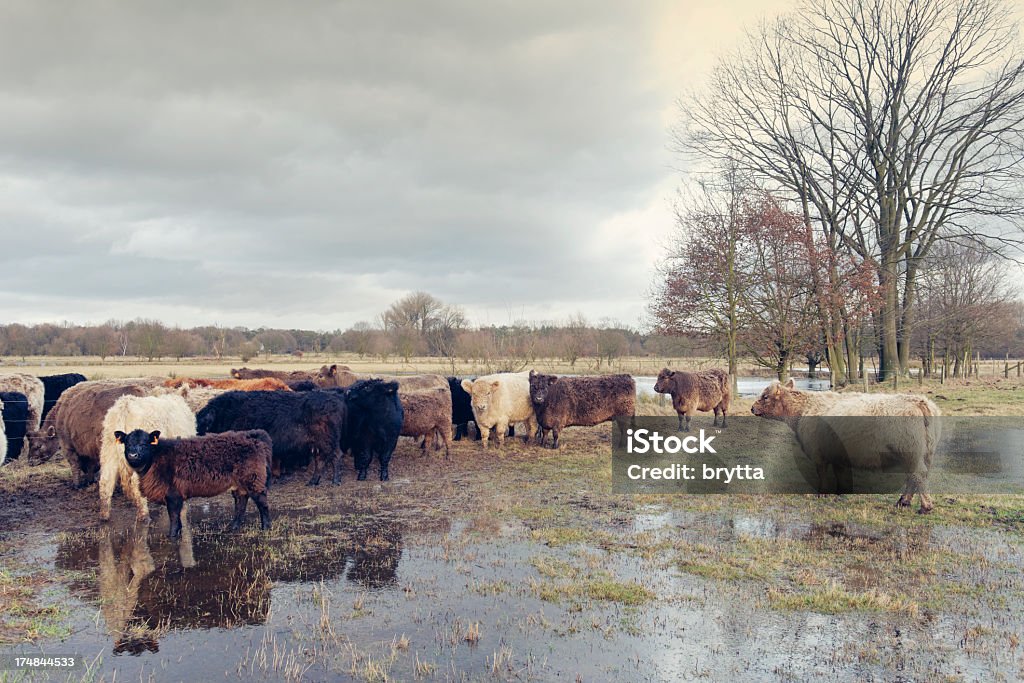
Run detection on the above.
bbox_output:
[462,373,537,449]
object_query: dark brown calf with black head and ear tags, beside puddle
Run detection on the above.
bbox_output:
[114,429,272,539]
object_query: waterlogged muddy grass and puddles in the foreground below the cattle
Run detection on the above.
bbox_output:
[0,416,1024,681]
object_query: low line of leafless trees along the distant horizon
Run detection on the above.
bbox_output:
[0,292,1024,367]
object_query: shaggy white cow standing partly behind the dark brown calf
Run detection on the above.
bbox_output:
[99,393,196,521]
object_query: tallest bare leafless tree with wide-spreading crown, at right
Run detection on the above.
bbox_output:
[677,0,1024,379]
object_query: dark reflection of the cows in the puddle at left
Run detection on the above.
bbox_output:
[56,511,415,654]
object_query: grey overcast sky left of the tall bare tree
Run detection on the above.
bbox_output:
[0,0,1019,330]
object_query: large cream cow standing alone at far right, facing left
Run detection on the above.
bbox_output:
[751,379,941,513]
